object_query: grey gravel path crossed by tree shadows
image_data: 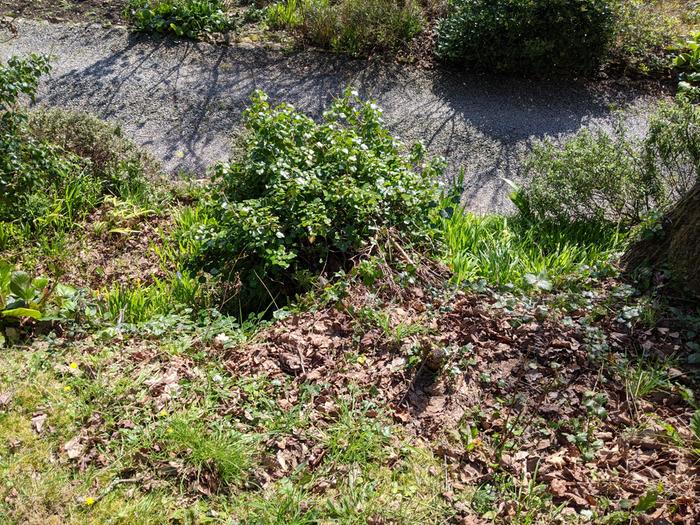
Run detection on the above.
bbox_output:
[0,20,653,211]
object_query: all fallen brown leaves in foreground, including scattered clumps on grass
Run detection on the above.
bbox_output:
[30,254,700,524]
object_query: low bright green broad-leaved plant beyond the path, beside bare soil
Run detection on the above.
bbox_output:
[125,0,233,39]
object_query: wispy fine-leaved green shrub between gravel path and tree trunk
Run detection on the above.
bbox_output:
[525,100,700,226]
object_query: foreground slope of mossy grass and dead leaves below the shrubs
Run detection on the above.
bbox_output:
[0,251,700,525]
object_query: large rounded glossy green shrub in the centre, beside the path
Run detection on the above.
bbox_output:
[187,92,442,309]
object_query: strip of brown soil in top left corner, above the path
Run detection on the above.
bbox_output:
[0,0,128,25]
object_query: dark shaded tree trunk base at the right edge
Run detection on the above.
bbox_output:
[622,182,700,297]
